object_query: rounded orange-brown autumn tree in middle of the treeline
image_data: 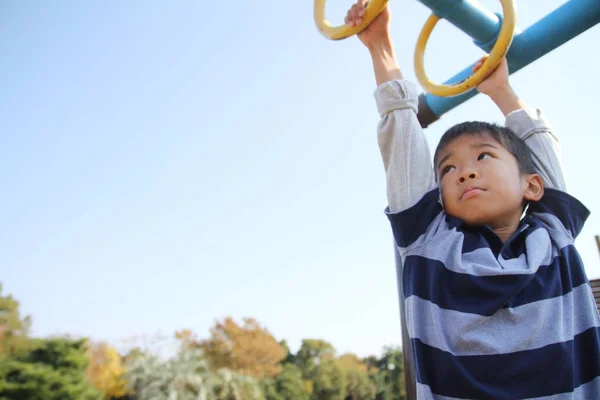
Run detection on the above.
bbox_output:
[196,318,287,377]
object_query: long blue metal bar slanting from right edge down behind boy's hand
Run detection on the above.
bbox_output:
[425,0,600,117]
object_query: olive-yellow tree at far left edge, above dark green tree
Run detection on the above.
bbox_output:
[0,283,31,360]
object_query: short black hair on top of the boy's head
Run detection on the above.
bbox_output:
[433,121,536,180]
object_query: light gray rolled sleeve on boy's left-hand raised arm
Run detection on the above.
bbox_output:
[375,80,435,213]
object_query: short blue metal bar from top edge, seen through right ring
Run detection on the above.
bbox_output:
[419,0,500,43]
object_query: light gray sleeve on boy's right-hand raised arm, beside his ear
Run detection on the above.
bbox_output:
[506,108,567,192]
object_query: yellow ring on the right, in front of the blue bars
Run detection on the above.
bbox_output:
[415,0,517,97]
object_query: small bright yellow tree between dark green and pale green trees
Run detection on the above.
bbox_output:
[86,342,127,398]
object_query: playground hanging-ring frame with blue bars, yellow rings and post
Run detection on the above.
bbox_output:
[314,0,600,400]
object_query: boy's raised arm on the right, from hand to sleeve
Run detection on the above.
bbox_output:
[474,59,567,192]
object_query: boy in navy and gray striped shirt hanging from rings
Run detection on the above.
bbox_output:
[345,0,600,399]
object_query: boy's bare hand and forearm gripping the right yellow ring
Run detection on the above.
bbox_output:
[473,56,526,116]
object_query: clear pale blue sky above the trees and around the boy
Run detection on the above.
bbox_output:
[0,0,600,355]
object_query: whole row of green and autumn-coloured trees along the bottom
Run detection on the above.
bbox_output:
[0,285,406,400]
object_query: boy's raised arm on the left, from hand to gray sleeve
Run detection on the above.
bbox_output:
[345,0,435,213]
